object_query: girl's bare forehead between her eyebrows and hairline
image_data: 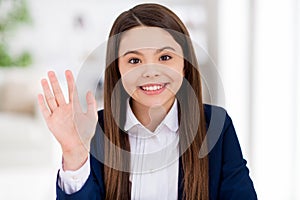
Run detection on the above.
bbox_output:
[119,26,182,55]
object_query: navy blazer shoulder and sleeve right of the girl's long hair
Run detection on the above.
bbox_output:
[204,104,257,199]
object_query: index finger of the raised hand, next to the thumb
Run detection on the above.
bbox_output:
[65,70,81,112]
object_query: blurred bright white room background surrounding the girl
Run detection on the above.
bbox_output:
[0,0,300,200]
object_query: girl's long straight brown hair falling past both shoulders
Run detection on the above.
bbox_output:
[104,4,209,200]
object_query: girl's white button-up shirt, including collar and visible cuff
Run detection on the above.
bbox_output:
[58,100,179,200]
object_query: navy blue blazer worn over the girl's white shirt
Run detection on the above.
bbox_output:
[56,105,257,200]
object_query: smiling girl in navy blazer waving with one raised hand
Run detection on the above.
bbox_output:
[38,4,257,200]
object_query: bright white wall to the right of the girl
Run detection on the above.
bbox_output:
[219,0,300,200]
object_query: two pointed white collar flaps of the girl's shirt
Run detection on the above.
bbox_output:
[124,98,178,132]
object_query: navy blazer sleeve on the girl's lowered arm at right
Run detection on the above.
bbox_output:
[219,113,257,200]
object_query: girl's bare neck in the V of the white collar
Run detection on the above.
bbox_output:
[131,99,174,132]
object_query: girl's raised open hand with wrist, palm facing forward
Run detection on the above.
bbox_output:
[38,70,98,170]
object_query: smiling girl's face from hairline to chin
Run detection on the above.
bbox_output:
[118,26,184,110]
